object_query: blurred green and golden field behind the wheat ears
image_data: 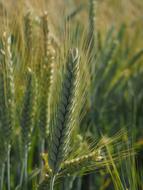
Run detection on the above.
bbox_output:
[0,0,143,190]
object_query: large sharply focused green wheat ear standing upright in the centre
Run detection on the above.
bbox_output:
[48,49,79,189]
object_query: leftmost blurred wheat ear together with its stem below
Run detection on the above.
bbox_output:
[0,32,15,189]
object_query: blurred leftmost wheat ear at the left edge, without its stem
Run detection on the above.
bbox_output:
[0,33,15,144]
